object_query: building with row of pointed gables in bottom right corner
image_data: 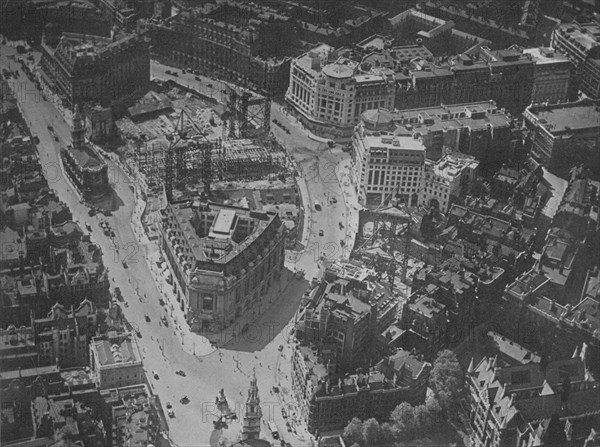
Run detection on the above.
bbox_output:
[467,349,600,447]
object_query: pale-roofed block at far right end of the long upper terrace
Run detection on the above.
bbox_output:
[523,47,573,103]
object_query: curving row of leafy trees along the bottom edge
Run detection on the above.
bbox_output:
[343,350,464,447]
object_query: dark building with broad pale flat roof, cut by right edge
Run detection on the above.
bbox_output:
[523,100,600,178]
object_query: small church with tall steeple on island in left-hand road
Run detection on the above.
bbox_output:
[61,106,109,198]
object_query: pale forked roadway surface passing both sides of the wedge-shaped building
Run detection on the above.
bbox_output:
[0,46,358,447]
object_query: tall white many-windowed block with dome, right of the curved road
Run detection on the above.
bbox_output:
[352,114,426,206]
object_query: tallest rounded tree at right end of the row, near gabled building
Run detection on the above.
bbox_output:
[429,349,464,414]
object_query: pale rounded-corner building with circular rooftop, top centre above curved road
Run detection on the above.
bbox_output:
[286,44,396,136]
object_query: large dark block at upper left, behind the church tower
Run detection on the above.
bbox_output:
[40,32,150,108]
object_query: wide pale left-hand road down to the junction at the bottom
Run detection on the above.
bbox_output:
[0,46,318,447]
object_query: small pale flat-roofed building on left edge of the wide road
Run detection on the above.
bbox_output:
[90,334,145,389]
